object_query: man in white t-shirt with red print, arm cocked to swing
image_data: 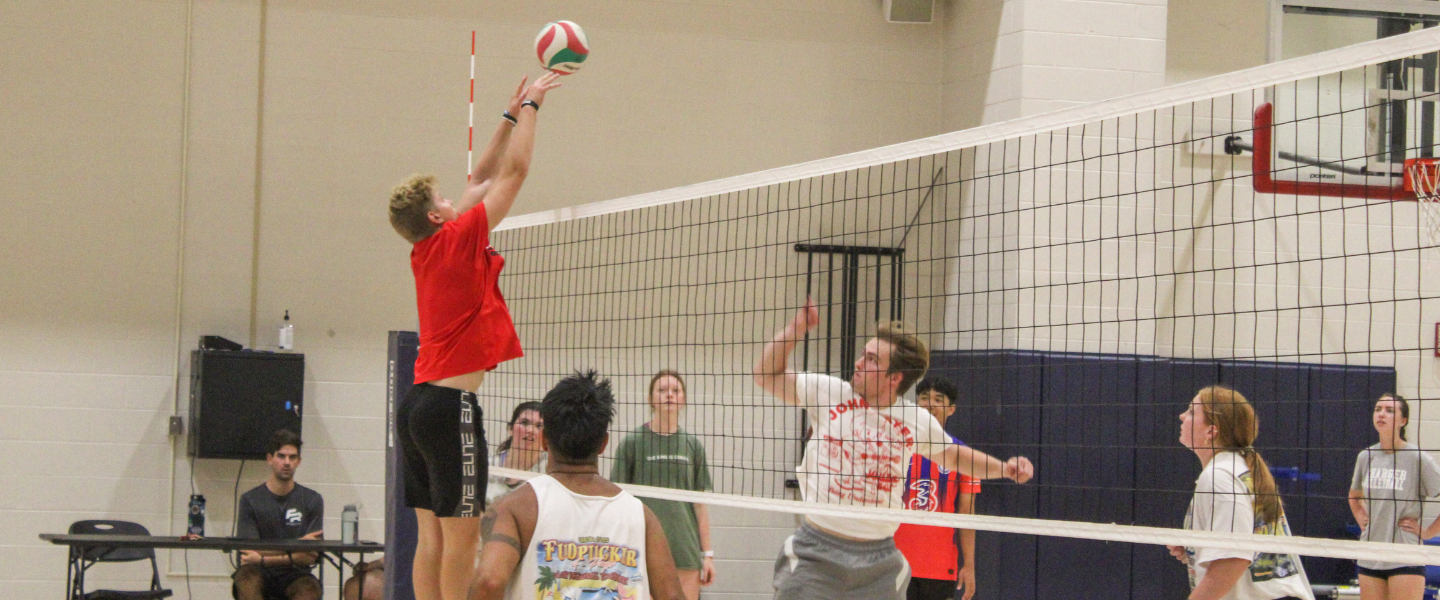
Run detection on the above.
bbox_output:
[755,301,1034,600]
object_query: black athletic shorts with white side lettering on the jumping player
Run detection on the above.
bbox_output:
[395,383,490,517]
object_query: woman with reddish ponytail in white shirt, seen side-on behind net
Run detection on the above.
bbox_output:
[1169,386,1315,600]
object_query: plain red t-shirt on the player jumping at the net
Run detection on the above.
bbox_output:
[410,204,524,383]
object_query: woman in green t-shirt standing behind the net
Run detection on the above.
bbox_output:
[611,370,716,600]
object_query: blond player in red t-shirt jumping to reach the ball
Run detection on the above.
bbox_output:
[390,73,560,600]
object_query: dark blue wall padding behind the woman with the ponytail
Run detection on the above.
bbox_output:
[930,350,1395,600]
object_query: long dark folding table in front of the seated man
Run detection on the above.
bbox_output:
[40,534,384,600]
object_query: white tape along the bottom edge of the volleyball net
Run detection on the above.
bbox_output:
[490,466,1440,564]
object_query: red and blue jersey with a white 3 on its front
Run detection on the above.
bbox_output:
[896,442,981,581]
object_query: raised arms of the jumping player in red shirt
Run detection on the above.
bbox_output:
[456,72,560,230]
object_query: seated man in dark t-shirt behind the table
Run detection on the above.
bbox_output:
[232,429,325,600]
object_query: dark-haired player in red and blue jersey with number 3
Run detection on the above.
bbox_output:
[896,376,981,600]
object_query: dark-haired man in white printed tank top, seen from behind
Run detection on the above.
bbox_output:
[469,371,684,600]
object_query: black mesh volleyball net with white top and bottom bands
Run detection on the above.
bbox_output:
[480,25,1440,597]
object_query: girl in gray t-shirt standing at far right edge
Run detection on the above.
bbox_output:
[1349,393,1440,600]
